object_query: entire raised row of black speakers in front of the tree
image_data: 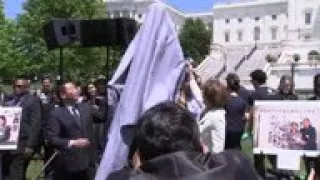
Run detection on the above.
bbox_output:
[43,18,137,50]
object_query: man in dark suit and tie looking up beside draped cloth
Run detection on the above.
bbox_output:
[46,82,104,180]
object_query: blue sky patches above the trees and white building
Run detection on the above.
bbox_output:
[5,0,243,18]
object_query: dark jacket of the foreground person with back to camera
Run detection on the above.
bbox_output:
[106,151,259,180]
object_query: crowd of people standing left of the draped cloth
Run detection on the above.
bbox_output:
[0,76,112,180]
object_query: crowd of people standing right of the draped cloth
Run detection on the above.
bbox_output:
[175,64,320,177]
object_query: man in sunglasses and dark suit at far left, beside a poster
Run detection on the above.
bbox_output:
[3,77,41,180]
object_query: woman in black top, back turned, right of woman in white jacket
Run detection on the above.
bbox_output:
[225,73,247,150]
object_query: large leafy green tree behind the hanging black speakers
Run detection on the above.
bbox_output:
[15,0,112,81]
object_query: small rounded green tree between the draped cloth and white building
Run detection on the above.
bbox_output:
[180,19,212,62]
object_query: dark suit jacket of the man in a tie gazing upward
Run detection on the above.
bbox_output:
[46,104,102,172]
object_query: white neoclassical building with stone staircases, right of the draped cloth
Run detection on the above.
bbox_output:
[208,0,320,97]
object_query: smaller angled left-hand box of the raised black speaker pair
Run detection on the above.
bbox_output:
[43,19,80,50]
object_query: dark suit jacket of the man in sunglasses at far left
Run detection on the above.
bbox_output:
[6,94,42,153]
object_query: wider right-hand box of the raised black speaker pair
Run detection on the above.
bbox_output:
[80,18,137,47]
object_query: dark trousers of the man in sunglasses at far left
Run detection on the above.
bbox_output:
[2,153,31,180]
